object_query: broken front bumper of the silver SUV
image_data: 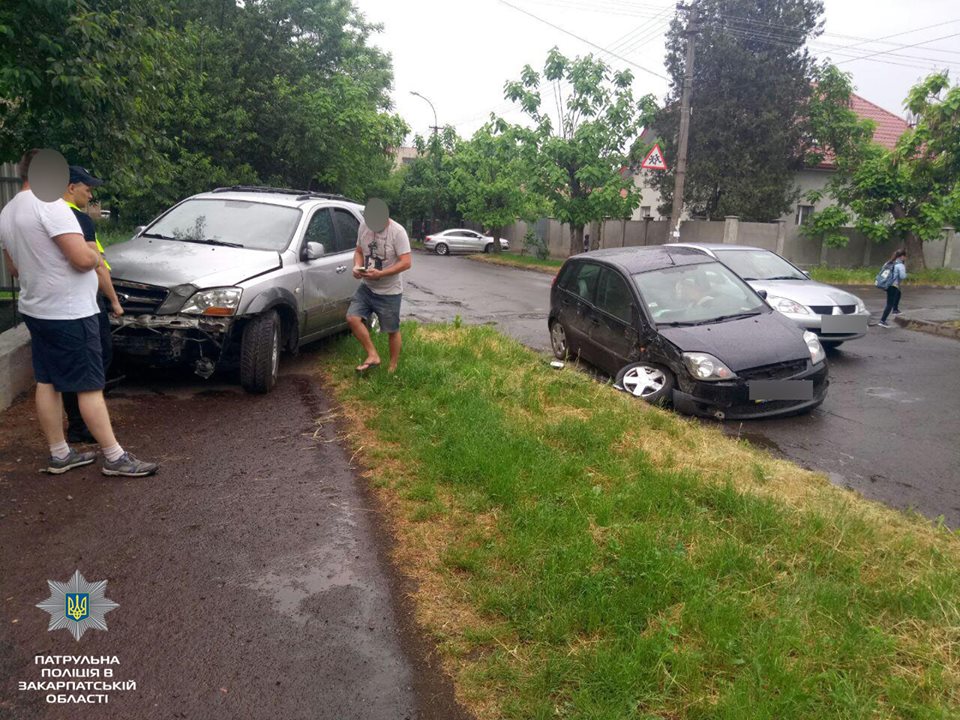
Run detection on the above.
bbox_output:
[110,315,236,377]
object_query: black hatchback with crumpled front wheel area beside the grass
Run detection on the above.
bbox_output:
[548,246,828,420]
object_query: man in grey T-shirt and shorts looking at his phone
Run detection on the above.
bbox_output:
[347,198,412,373]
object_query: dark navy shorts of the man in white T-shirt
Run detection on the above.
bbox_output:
[23,315,104,392]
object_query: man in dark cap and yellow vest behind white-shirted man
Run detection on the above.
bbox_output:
[63,165,123,443]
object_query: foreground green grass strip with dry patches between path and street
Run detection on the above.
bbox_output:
[324,324,960,720]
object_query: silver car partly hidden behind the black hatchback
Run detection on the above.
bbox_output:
[672,243,870,347]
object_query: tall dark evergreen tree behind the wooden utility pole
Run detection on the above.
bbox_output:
[653,0,823,222]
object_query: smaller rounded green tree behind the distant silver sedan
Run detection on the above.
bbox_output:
[451,120,543,253]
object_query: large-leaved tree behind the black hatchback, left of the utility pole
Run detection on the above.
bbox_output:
[504,48,654,254]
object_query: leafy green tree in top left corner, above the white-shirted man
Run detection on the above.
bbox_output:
[0,0,183,208]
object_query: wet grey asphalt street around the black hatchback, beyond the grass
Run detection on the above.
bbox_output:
[404,253,960,528]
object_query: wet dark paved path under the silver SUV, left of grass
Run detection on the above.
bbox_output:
[0,351,464,720]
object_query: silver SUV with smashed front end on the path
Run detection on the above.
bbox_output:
[107,186,363,393]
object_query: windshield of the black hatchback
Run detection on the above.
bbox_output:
[633,262,769,325]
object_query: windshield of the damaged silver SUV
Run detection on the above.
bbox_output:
[144,198,300,252]
